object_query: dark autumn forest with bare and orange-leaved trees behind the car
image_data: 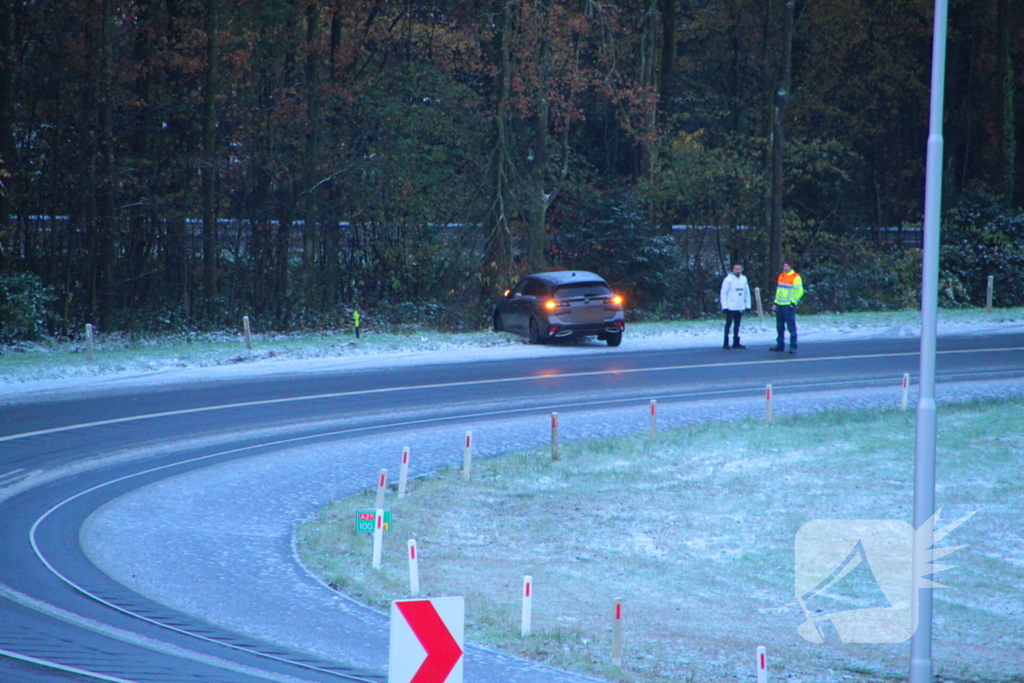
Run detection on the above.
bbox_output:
[0,0,1024,342]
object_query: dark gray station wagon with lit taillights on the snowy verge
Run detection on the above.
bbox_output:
[494,270,626,346]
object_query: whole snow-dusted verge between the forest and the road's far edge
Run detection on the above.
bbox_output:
[0,308,1024,402]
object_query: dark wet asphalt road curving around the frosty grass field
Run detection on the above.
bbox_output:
[0,335,1024,683]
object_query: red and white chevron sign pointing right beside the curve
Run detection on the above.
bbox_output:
[387,597,466,683]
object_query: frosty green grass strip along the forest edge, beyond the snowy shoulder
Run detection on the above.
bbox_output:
[0,308,1024,387]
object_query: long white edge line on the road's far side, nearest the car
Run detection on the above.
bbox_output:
[0,347,1024,442]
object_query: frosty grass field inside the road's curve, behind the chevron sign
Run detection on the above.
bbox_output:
[298,400,1024,683]
